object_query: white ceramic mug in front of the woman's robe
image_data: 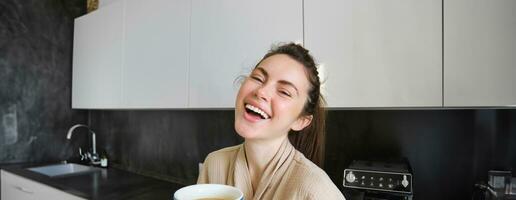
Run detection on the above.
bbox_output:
[174,184,244,200]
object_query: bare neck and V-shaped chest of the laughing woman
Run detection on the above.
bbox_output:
[244,137,288,191]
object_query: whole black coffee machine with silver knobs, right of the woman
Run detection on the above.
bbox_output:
[343,160,414,200]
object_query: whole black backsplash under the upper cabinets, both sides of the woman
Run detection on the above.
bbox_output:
[91,110,516,199]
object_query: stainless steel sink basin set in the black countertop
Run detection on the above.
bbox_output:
[27,163,100,177]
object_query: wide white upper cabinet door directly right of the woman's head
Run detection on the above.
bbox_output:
[304,0,442,107]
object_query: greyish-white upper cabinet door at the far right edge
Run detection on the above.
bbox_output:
[444,0,516,106]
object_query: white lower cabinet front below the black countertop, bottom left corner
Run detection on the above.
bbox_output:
[1,170,84,200]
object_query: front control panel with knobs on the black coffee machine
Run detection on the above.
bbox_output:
[343,169,412,194]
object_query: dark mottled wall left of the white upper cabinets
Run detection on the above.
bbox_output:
[0,0,87,163]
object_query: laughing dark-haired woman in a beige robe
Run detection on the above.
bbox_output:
[198,43,344,199]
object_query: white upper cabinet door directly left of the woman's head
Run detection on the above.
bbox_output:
[189,0,303,108]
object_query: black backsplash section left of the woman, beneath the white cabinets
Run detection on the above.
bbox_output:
[91,111,242,184]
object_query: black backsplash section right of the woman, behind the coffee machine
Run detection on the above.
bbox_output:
[325,110,516,199]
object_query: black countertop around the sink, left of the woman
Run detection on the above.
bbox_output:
[0,164,184,200]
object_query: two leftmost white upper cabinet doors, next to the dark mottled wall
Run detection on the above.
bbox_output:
[72,0,190,109]
